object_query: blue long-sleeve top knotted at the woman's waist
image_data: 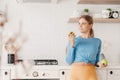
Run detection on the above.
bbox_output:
[66,36,101,65]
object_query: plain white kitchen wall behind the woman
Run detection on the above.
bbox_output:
[0,0,120,65]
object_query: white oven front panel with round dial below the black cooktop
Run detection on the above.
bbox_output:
[12,69,60,79]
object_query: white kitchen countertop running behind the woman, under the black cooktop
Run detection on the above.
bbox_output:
[0,59,120,69]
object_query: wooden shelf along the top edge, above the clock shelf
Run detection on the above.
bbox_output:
[78,0,120,4]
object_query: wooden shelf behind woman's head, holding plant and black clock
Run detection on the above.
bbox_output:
[68,18,120,23]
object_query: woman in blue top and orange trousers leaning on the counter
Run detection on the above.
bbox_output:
[66,15,106,80]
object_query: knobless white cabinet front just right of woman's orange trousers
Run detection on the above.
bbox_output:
[97,69,107,80]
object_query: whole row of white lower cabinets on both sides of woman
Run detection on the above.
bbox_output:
[0,66,120,80]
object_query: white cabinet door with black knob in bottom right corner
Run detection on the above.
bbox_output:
[107,69,120,80]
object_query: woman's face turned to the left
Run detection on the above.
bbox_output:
[79,18,92,33]
